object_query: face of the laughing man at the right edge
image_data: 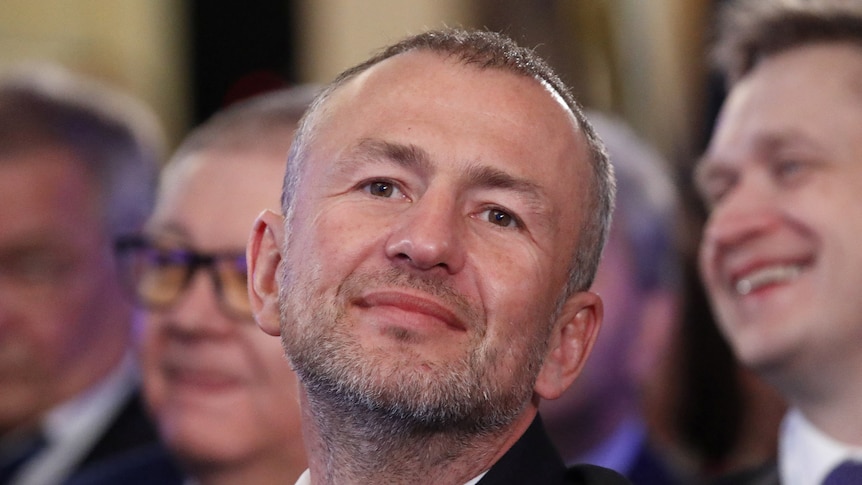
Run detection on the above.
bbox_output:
[697,44,862,382]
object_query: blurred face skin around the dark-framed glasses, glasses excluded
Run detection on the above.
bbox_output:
[142,147,305,466]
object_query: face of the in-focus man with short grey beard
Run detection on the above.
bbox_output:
[281,52,591,426]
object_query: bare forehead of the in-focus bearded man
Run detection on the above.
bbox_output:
[310,50,589,195]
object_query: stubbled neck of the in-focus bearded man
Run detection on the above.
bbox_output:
[302,392,536,485]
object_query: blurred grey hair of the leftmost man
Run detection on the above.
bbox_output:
[0,64,164,236]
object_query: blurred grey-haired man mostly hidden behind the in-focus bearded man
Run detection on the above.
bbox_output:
[539,113,681,485]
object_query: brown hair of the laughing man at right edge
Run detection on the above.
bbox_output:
[713,0,862,84]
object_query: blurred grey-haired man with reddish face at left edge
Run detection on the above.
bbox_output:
[0,68,162,485]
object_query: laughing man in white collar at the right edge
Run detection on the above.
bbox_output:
[696,0,862,485]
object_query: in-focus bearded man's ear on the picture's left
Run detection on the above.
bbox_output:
[246,210,284,336]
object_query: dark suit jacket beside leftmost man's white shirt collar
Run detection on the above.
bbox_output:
[59,391,176,483]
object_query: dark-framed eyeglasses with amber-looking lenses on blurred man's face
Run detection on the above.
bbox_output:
[116,236,252,319]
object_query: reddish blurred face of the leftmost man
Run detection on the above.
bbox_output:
[0,147,131,434]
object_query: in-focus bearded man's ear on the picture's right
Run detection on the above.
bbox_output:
[534,291,604,399]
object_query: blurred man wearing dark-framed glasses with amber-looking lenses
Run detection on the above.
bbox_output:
[76,88,314,485]
